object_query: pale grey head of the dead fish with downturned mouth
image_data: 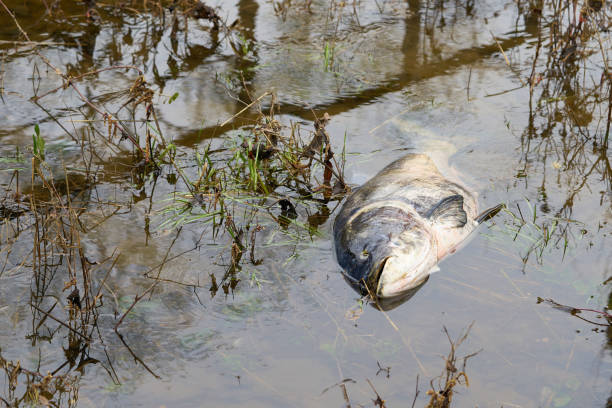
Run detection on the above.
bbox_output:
[337,204,437,298]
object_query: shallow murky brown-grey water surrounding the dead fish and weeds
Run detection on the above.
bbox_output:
[0,0,612,408]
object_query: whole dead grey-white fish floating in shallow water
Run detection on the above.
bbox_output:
[333,154,503,298]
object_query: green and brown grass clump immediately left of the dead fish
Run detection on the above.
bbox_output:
[157,94,348,292]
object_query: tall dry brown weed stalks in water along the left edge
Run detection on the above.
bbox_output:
[0,155,129,406]
